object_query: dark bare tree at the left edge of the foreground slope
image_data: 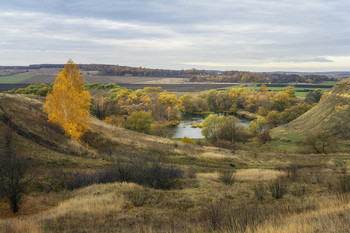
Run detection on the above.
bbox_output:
[0,126,32,213]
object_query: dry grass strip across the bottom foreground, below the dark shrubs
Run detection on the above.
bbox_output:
[0,177,350,233]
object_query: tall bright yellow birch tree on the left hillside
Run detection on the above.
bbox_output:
[44,60,90,140]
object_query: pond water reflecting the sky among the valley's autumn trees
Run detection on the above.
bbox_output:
[171,114,251,138]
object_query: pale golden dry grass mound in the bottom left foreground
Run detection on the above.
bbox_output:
[0,183,128,233]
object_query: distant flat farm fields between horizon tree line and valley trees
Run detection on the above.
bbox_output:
[0,68,337,97]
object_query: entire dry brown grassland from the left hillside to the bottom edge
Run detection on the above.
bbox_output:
[0,94,350,233]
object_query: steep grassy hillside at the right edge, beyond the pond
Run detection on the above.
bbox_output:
[275,78,350,139]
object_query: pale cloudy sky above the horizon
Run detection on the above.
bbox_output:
[0,0,350,72]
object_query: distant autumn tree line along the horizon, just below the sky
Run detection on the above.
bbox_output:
[0,64,336,83]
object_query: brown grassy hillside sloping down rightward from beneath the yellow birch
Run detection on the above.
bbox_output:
[0,94,254,173]
